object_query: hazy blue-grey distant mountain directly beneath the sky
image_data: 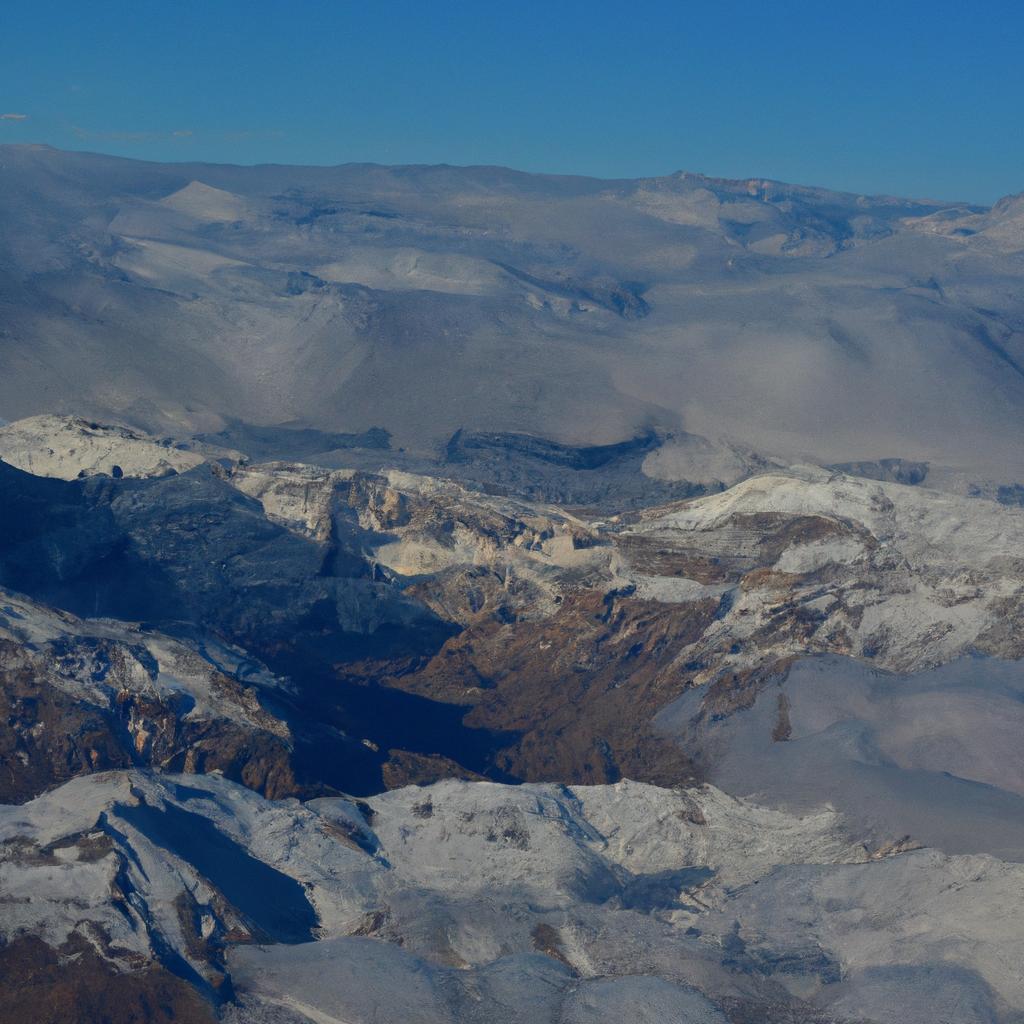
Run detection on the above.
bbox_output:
[0,146,1024,484]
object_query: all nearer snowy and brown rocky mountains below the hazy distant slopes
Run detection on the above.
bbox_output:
[0,417,1024,1024]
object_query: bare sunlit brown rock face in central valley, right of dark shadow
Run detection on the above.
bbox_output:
[389,591,718,785]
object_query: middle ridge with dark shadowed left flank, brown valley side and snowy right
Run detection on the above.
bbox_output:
[0,409,1024,788]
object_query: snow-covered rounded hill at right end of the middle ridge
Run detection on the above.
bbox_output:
[620,467,1024,678]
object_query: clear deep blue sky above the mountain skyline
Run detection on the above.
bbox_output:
[0,0,1024,202]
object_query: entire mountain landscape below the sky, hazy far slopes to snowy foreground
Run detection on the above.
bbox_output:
[0,146,1024,1024]
